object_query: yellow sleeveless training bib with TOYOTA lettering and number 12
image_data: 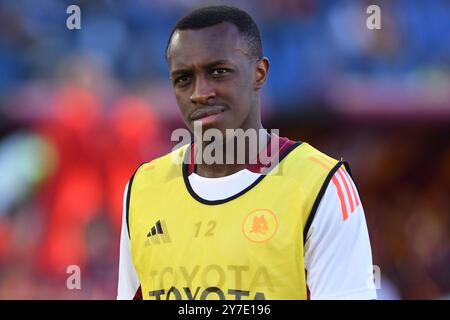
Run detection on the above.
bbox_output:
[127,143,341,300]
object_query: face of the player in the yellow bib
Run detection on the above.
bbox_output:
[167,23,265,133]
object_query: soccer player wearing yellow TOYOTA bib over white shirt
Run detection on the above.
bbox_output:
[118,6,376,300]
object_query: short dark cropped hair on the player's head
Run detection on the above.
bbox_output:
[166,6,263,58]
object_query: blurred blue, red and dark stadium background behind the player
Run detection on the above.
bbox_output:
[0,0,450,299]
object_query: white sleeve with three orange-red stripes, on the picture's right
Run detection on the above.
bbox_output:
[305,167,376,300]
